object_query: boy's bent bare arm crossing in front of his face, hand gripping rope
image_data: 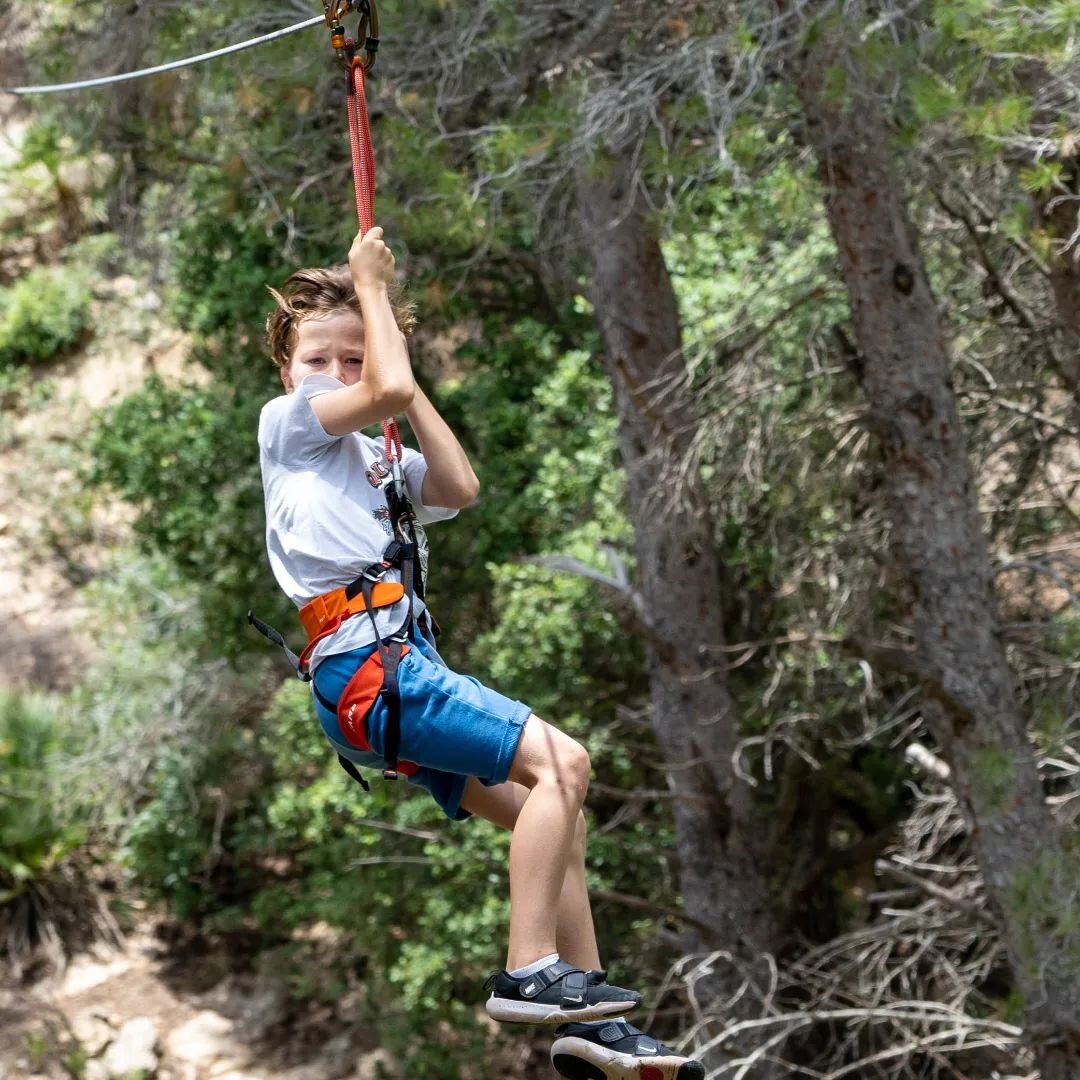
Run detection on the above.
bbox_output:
[311,227,416,435]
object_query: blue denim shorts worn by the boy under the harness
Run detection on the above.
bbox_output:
[314,632,531,821]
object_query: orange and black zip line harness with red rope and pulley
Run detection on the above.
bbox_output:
[247,0,426,791]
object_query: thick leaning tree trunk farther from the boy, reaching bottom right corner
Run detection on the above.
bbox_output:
[792,19,1080,1080]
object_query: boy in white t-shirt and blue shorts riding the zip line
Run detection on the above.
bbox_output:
[259,228,704,1080]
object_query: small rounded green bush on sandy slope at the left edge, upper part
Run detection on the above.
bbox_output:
[0,267,91,367]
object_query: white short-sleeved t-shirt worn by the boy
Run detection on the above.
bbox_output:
[259,374,457,670]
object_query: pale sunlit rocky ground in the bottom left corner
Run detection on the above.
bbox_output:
[0,929,393,1080]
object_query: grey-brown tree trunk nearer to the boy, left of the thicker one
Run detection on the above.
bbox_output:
[578,143,777,1002]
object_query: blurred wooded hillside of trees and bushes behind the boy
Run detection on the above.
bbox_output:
[0,0,1080,1080]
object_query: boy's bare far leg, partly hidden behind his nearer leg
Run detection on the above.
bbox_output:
[461,778,600,971]
